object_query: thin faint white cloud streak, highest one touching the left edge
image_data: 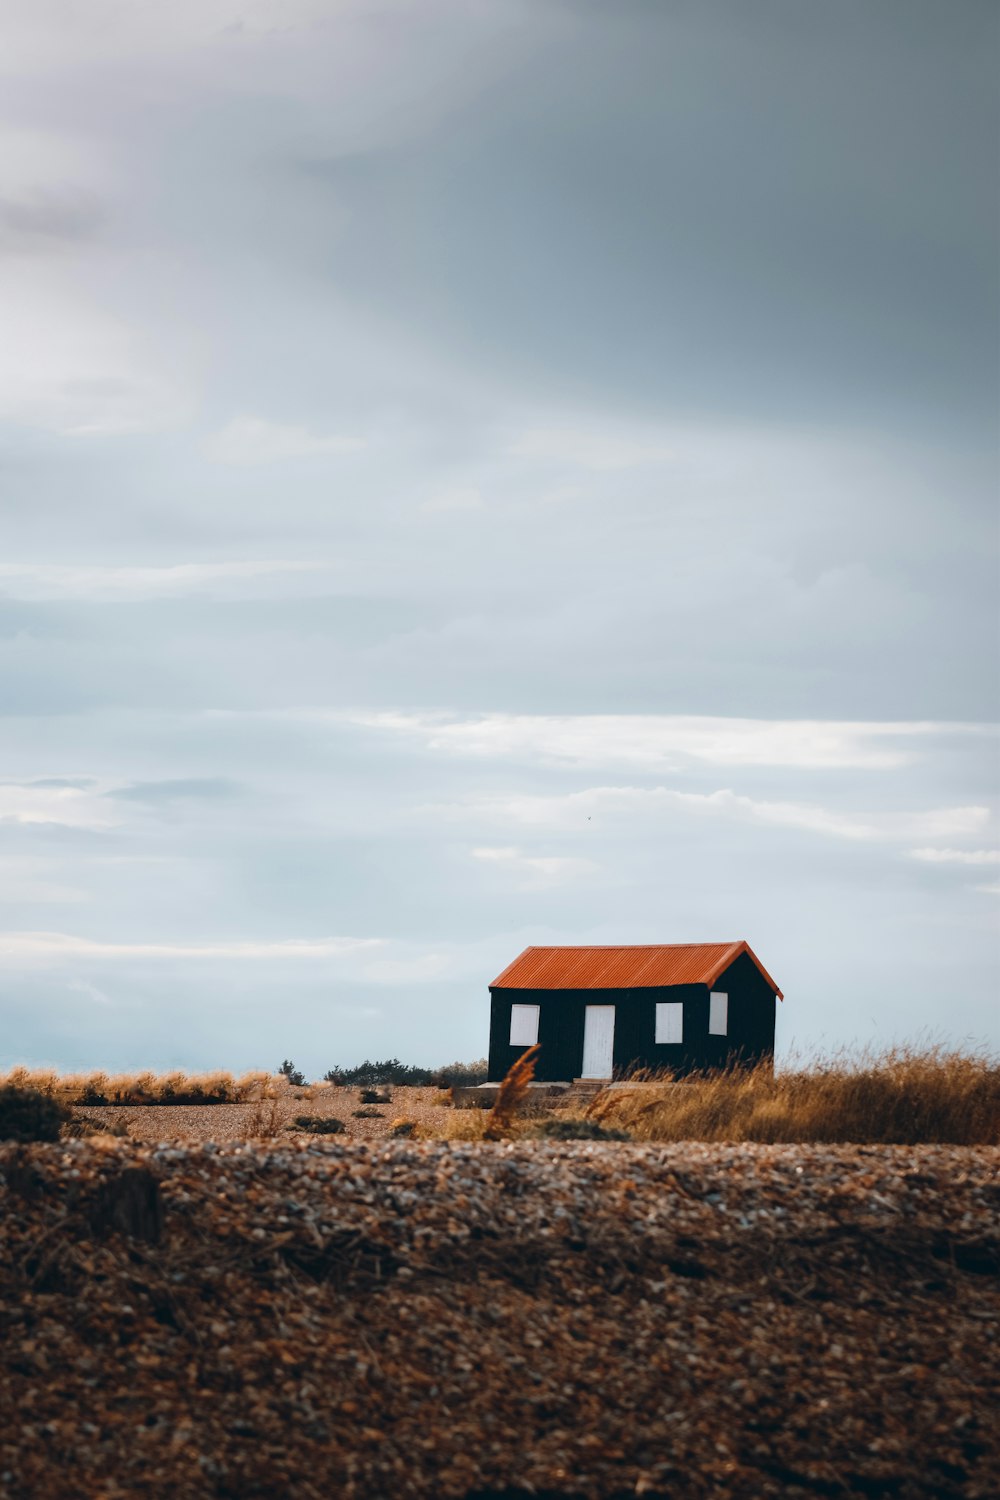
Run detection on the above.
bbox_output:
[0,558,327,603]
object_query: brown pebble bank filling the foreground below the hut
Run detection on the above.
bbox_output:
[0,1137,1000,1500]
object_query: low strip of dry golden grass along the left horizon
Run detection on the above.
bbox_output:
[0,1068,277,1104]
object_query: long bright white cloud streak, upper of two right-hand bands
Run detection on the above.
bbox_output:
[349,713,996,770]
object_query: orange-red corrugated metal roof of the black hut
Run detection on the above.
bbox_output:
[490,942,783,999]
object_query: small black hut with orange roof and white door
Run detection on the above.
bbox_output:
[489,942,783,1083]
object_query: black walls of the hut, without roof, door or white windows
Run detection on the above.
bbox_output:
[489,953,777,1083]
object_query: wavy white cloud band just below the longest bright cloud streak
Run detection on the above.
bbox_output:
[442,786,990,854]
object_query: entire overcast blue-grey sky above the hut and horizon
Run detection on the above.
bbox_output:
[0,0,1000,1076]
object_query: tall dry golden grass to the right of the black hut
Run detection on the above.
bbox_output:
[588,1047,1000,1146]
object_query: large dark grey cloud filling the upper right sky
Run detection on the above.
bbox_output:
[310,6,996,428]
